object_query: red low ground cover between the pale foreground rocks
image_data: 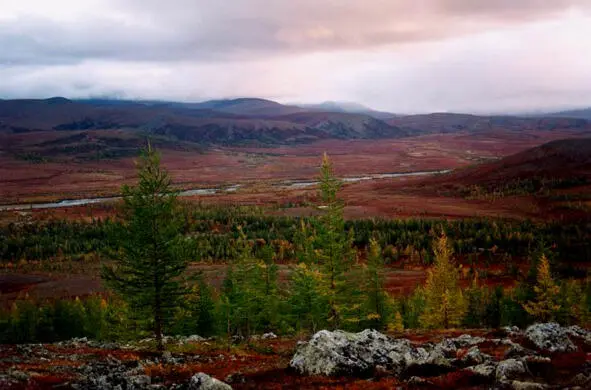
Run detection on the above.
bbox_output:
[0,330,591,390]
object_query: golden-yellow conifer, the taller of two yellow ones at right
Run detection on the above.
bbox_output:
[421,235,466,329]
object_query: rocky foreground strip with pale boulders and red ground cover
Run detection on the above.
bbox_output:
[0,323,591,390]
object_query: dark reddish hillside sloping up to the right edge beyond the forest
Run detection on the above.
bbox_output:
[416,138,591,206]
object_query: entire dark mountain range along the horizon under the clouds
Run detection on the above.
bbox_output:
[0,97,591,158]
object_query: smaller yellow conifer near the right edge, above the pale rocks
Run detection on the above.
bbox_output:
[523,255,560,321]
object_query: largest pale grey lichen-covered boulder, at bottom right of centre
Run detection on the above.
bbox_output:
[290,330,417,376]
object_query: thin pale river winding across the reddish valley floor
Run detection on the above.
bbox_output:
[0,169,451,211]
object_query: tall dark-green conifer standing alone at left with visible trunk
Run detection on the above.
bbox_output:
[102,145,188,351]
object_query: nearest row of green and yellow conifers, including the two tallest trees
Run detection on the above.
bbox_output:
[0,149,591,350]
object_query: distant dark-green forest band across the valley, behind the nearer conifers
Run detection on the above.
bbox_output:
[0,204,591,265]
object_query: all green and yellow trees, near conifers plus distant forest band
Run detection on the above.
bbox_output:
[0,149,591,344]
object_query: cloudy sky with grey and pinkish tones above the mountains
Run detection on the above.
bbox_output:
[0,0,591,114]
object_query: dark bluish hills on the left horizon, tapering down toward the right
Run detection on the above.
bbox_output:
[0,98,406,158]
